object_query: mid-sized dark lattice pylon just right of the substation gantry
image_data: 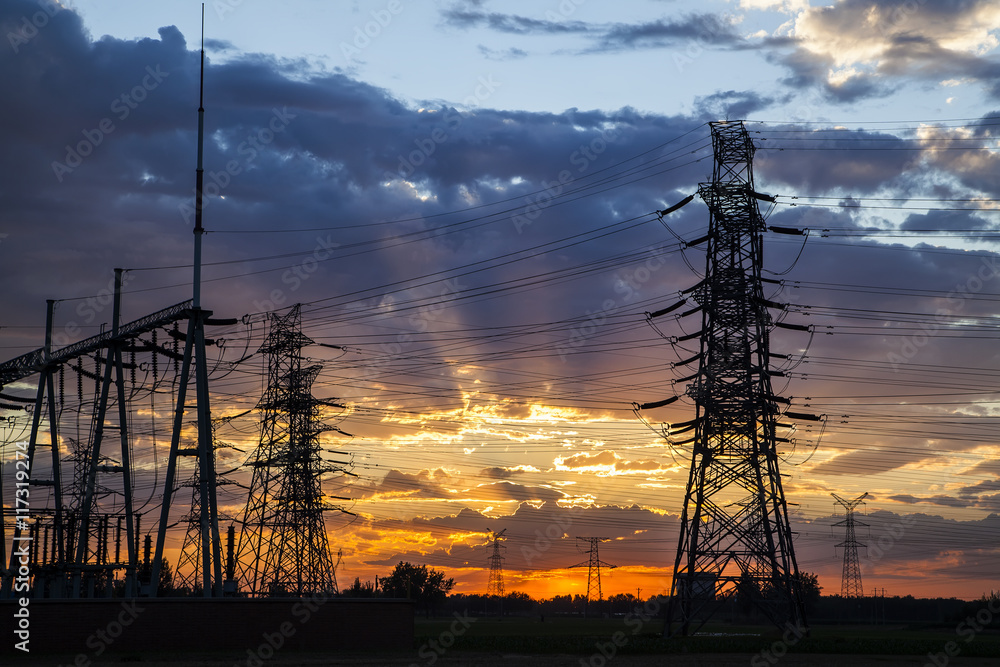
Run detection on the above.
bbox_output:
[236,305,351,597]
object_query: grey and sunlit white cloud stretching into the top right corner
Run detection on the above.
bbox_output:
[442,0,1000,104]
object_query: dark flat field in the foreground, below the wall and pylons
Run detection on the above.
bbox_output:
[9,616,1000,667]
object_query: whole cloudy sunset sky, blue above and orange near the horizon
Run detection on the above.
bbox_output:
[0,0,1000,597]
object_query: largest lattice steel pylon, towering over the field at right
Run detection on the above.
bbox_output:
[664,121,805,635]
